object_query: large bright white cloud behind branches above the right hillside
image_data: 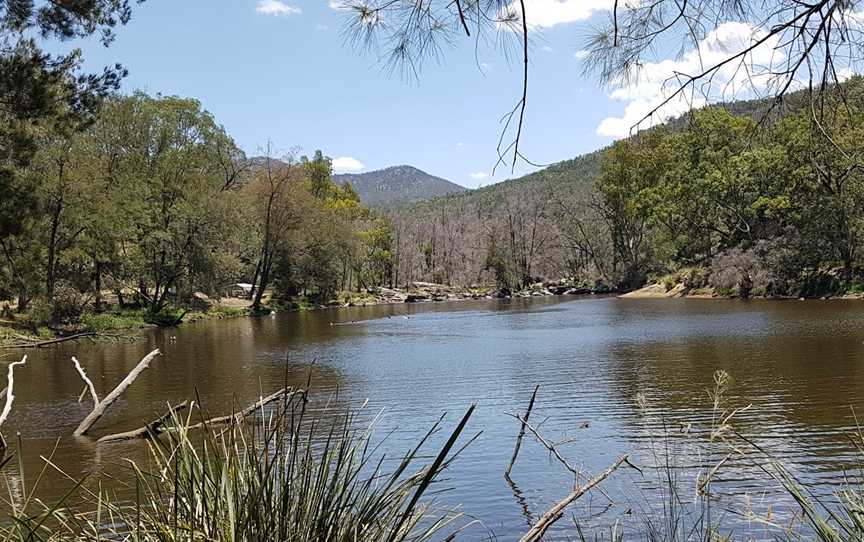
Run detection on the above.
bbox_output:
[597,22,783,137]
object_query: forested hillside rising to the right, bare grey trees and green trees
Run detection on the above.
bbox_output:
[388,78,864,296]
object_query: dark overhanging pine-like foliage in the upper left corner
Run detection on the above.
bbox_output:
[0,0,141,238]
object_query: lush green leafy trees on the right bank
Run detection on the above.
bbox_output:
[597,78,864,296]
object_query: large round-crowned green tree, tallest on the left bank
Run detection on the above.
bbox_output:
[104,93,241,312]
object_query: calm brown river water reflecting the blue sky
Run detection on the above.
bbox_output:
[3,298,864,540]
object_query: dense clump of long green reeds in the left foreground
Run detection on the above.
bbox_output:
[0,398,473,542]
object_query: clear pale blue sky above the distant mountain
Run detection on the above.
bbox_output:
[57,0,768,187]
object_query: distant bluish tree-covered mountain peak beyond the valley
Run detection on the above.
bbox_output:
[333,166,468,207]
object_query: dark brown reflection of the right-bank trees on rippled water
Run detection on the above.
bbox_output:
[608,309,864,472]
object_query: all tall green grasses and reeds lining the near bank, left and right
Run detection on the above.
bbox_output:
[8,372,864,542]
